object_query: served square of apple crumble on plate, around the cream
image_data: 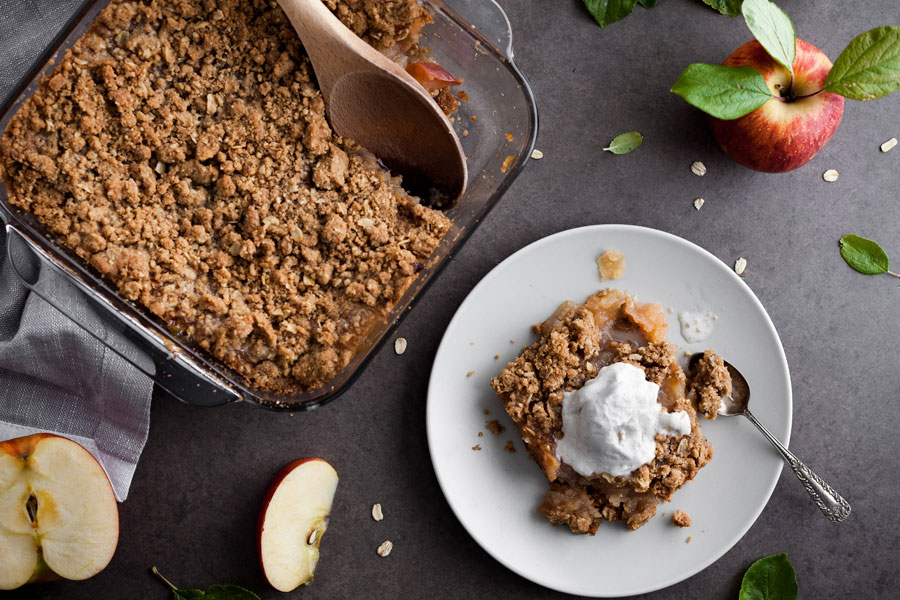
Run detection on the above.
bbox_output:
[491,290,727,534]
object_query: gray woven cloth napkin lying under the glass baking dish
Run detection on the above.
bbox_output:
[0,0,153,501]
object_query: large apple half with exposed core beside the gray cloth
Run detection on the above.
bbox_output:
[0,433,119,590]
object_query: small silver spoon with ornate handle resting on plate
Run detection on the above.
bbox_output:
[688,352,850,523]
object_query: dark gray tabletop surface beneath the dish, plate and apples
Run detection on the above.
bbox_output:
[0,0,900,600]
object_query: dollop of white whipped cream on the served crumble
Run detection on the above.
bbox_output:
[556,363,691,477]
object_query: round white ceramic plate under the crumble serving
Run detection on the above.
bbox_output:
[427,225,791,597]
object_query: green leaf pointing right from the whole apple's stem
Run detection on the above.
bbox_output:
[825,25,900,100]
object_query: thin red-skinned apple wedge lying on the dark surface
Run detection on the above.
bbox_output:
[257,458,338,592]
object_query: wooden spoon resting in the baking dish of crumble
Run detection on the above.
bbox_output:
[278,0,467,208]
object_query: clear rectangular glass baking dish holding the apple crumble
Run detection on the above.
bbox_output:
[0,0,537,411]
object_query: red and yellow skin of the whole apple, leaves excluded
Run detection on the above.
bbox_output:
[710,39,844,173]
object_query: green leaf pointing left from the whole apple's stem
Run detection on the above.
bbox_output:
[670,63,772,120]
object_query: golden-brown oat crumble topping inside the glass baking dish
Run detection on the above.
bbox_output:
[0,0,449,393]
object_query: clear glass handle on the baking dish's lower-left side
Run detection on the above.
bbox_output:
[6,224,241,406]
